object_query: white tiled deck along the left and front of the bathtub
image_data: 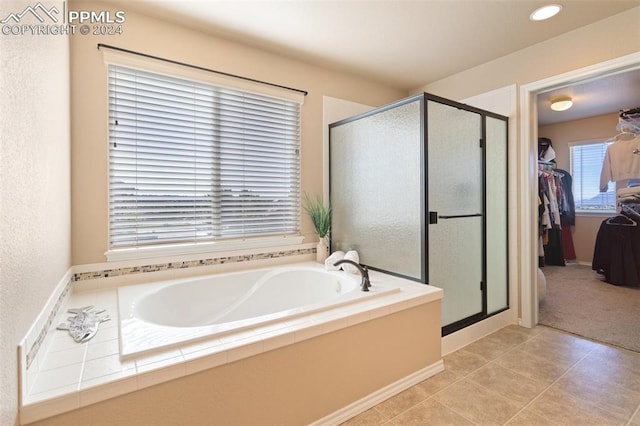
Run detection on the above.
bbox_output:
[21,264,442,424]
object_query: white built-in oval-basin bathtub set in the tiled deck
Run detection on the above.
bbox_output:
[118,262,400,358]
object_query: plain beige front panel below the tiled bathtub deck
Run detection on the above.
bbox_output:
[28,300,441,426]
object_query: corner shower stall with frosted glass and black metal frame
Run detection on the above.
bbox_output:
[329,93,509,336]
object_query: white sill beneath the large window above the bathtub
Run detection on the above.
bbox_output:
[105,235,304,262]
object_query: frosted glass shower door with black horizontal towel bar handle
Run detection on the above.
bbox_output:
[427,100,485,334]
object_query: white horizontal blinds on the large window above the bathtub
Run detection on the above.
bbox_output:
[109,64,300,249]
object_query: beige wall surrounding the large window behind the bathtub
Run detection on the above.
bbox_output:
[69,0,407,264]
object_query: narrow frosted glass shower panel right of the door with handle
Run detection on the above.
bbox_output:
[486,117,509,314]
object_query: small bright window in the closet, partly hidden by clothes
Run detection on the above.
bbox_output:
[569,142,616,213]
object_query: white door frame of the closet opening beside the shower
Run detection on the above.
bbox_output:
[518,52,640,327]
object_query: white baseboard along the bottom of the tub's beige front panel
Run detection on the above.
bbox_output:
[311,360,444,426]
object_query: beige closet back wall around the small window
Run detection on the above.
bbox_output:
[538,113,618,264]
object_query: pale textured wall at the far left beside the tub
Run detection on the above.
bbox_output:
[0,1,71,425]
